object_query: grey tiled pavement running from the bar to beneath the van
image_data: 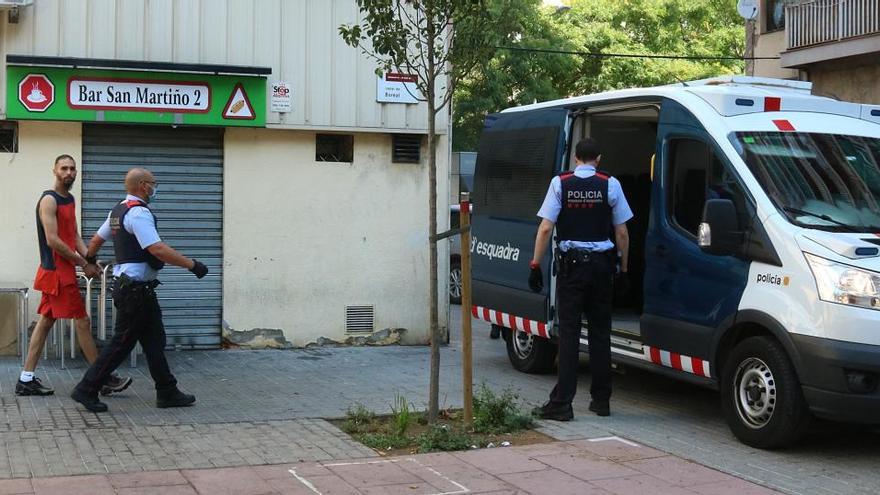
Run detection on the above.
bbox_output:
[0,313,880,494]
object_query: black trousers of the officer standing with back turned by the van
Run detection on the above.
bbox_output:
[550,249,616,405]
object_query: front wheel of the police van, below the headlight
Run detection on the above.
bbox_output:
[721,337,810,449]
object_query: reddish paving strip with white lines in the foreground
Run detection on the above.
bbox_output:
[0,437,778,495]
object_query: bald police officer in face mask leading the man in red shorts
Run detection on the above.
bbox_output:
[70,168,208,412]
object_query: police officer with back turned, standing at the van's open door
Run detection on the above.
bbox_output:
[529,138,633,421]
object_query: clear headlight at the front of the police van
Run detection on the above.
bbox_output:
[804,253,880,309]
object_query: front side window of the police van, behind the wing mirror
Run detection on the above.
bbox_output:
[667,138,749,237]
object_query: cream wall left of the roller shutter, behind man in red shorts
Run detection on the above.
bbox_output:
[0,122,82,348]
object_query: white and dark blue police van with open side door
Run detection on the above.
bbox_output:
[471,76,880,448]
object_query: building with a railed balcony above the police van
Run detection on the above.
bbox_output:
[755,0,880,103]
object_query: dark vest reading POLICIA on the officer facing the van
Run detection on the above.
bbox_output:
[556,172,611,242]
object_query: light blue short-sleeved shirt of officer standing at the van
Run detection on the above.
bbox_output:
[538,163,633,251]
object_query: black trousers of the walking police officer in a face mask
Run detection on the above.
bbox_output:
[76,276,177,397]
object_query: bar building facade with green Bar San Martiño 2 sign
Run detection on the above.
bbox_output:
[0,0,449,354]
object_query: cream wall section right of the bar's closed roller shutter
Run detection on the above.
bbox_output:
[223,128,448,346]
